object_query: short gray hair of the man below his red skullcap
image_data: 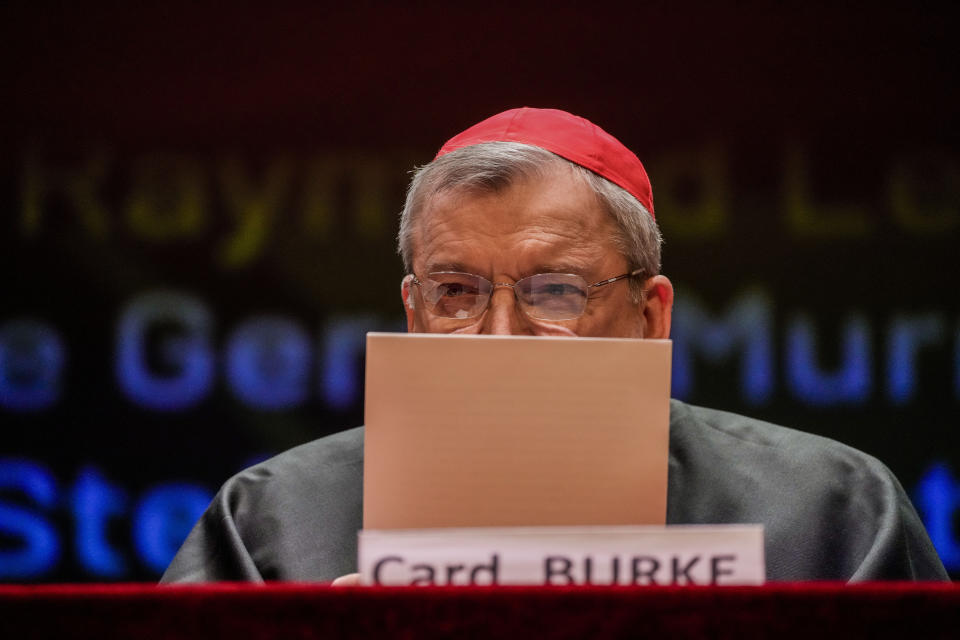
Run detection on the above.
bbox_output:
[397,142,663,301]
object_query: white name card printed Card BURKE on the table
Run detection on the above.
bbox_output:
[359,525,766,586]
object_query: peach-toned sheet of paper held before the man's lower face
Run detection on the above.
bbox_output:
[363,333,671,529]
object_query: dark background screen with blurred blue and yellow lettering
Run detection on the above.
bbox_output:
[0,3,960,581]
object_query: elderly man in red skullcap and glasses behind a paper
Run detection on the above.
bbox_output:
[163,108,946,582]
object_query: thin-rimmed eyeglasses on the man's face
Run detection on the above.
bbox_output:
[413,269,643,321]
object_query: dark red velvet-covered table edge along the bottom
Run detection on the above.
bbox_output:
[0,583,960,638]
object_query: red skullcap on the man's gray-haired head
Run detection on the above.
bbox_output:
[434,107,653,216]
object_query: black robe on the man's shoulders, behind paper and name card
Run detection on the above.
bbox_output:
[162,400,947,582]
